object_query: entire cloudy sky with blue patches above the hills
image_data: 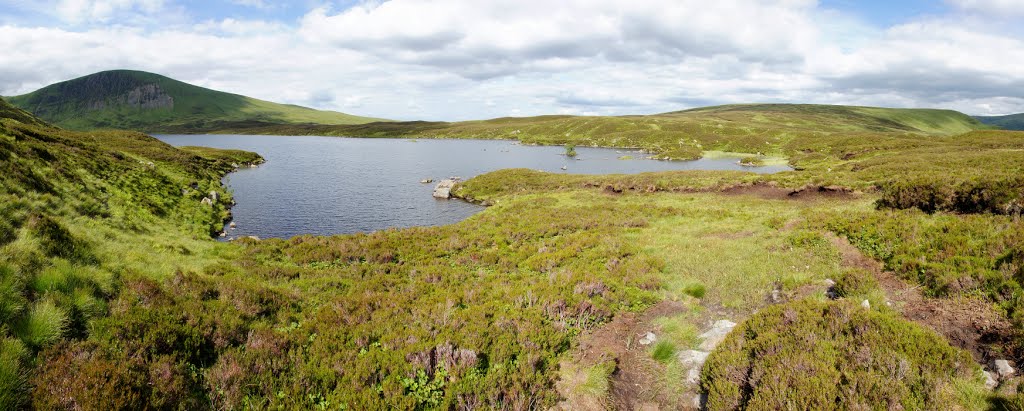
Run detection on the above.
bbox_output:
[0,0,1024,121]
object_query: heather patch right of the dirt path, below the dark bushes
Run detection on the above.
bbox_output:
[814,210,1024,330]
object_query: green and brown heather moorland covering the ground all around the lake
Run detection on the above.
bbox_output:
[0,93,1024,409]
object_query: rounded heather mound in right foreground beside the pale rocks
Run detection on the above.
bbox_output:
[700,299,981,410]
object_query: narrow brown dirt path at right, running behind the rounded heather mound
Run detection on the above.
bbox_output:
[830,232,1017,364]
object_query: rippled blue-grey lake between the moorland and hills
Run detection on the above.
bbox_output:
[157,135,788,238]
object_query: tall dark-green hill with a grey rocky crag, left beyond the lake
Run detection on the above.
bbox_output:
[8,70,382,132]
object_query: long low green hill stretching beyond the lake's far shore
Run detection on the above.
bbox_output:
[223,105,988,159]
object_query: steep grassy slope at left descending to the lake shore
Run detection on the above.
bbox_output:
[0,99,261,410]
